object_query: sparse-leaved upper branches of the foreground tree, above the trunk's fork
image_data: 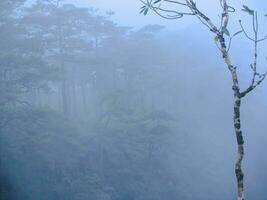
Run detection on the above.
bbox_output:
[140,0,267,98]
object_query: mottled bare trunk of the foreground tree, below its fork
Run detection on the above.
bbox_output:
[234,95,245,200]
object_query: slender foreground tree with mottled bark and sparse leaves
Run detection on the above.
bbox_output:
[140,0,267,200]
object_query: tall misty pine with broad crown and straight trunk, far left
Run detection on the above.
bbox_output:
[23,1,96,117]
